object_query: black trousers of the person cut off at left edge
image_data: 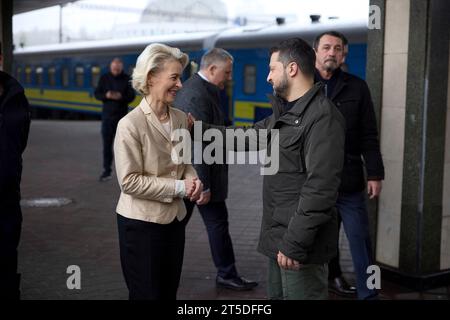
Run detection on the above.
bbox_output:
[0,199,22,300]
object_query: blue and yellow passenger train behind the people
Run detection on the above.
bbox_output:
[14,21,367,125]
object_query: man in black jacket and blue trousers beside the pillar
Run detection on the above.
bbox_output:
[314,31,384,299]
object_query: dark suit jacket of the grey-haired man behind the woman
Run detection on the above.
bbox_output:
[174,74,230,202]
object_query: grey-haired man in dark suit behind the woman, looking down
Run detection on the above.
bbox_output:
[174,48,257,290]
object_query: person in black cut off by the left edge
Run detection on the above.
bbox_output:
[0,43,30,300]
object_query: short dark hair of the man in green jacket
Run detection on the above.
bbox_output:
[270,38,316,78]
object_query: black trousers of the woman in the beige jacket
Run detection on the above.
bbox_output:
[117,214,186,300]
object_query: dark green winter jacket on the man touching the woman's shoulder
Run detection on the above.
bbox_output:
[198,84,345,264]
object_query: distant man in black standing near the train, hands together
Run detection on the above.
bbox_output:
[95,58,136,181]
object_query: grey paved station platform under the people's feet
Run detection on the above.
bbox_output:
[15,120,450,300]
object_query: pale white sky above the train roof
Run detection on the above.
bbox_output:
[14,0,369,33]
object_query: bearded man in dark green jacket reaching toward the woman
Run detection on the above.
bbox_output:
[191,38,345,299]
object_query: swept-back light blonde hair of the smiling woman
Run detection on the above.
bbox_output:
[131,43,189,95]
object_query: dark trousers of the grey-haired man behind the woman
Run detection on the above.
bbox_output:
[184,200,238,279]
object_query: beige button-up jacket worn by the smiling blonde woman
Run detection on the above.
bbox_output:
[114,99,197,224]
